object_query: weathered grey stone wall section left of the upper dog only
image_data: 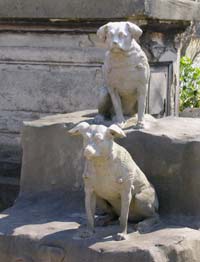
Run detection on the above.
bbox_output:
[0,29,104,209]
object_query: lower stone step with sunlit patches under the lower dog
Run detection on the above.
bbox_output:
[0,192,200,262]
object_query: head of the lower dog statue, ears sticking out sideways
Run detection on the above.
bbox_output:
[69,122,126,160]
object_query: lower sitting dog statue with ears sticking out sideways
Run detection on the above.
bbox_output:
[69,122,158,240]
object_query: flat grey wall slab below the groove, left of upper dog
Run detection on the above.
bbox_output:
[0,64,100,113]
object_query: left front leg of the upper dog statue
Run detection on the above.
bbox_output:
[109,88,125,127]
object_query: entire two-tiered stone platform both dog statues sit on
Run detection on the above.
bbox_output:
[0,111,200,262]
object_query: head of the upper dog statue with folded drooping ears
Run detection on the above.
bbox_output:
[97,22,142,52]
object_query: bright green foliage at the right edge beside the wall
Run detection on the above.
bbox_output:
[180,56,200,111]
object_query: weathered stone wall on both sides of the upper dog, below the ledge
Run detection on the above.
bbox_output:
[0,24,188,209]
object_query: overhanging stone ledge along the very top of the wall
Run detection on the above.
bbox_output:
[0,0,200,20]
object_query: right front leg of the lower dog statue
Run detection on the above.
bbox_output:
[116,186,132,240]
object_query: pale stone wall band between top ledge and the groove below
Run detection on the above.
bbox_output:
[0,32,105,64]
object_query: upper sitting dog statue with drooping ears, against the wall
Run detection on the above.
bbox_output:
[96,22,150,128]
